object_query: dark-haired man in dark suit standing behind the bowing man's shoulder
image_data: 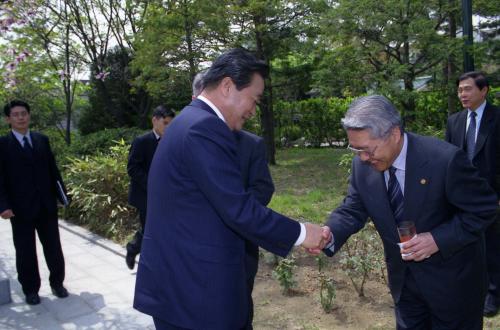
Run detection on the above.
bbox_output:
[446,71,500,316]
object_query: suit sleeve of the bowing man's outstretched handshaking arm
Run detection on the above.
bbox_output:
[325,161,368,255]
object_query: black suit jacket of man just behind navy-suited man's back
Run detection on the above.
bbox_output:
[127,131,158,212]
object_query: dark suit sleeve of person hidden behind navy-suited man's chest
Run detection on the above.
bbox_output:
[247,139,274,205]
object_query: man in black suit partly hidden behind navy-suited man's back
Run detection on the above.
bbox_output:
[125,105,175,269]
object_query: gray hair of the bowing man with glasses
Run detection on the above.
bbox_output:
[342,95,403,139]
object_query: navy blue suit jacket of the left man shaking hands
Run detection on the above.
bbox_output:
[134,100,300,329]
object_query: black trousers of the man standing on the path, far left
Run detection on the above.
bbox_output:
[10,208,64,294]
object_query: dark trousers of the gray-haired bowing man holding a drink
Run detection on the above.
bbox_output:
[396,270,483,330]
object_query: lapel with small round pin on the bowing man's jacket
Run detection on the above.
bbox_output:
[403,133,431,227]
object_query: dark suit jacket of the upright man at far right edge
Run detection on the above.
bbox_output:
[446,103,500,199]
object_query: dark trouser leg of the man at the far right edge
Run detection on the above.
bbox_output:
[484,213,500,307]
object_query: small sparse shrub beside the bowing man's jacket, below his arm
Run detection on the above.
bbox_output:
[339,221,386,297]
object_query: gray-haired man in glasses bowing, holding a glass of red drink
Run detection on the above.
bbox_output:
[324,95,497,329]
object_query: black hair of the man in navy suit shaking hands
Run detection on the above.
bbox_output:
[203,48,269,90]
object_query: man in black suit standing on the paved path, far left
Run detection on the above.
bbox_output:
[0,100,68,305]
